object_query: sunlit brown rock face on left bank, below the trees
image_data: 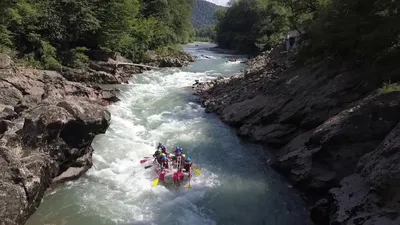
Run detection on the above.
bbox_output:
[0,66,118,225]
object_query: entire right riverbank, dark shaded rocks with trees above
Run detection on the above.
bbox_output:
[194,0,400,225]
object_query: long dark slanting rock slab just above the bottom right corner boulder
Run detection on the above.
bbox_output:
[272,92,400,192]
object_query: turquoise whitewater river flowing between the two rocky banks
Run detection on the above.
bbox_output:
[26,43,311,225]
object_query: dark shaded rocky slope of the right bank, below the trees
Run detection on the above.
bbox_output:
[193,50,400,225]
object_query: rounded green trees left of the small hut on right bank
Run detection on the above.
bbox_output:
[216,0,290,52]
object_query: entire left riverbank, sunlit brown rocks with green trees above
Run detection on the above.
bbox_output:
[0,0,194,225]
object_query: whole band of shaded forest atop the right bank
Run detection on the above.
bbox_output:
[215,0,400,64]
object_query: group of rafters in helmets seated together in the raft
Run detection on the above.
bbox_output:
[153,143,192,178]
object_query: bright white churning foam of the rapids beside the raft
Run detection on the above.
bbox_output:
[77,69,219,224]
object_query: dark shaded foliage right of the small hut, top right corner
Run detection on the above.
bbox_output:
[300,0,400,65]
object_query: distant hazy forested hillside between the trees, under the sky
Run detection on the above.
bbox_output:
[192,0,223,29]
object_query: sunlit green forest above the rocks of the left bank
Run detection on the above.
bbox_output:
[0,0,195,69]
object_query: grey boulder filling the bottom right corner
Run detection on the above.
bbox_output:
[319,124,400,225]
